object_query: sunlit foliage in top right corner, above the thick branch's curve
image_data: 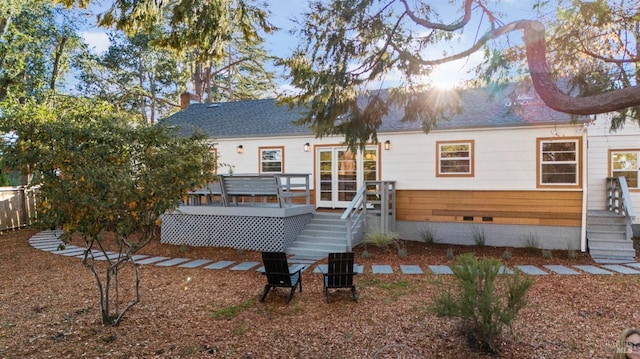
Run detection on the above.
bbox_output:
[520,0,640,129]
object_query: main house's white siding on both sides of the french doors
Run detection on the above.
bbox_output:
[210,125,584,194]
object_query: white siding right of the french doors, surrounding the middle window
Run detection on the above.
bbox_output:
[379,126,582,190]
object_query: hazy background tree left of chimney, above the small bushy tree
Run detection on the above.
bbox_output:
[78,32,188,123]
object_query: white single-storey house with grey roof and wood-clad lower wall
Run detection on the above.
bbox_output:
[163,89,640,258]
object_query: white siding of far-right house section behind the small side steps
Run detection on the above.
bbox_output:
[588,116,640,223]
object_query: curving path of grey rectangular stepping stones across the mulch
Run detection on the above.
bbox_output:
[29,231,640,276]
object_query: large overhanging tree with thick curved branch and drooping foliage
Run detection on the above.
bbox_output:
[280,0,640,146]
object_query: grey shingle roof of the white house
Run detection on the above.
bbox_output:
[162,88,584,138]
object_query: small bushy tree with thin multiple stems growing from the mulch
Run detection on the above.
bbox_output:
[0,97,214,325]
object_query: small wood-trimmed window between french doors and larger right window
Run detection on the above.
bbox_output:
[436,141,474,177]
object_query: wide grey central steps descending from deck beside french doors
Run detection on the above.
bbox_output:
[287,212,347,263]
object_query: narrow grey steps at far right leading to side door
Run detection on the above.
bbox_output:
[587,211,636,263]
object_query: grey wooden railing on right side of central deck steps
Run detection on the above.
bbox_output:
[341,181,396,251]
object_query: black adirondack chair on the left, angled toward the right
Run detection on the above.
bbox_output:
[260,252,304,303]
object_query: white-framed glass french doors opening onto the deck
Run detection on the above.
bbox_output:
[315,146,378,208]
